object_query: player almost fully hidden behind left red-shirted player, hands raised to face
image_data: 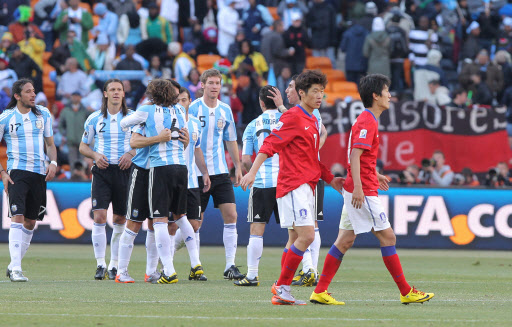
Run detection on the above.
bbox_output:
[271,75,327,286]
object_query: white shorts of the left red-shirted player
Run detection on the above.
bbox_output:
[277,184,315,228]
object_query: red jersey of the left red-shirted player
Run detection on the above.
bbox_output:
[259,106,334,198]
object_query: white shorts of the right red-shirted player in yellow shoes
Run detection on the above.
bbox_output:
[340,190,391,235]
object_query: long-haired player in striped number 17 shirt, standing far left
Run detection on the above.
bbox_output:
[0,78,57,282]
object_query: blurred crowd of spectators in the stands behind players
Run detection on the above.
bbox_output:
[0,0,512,186]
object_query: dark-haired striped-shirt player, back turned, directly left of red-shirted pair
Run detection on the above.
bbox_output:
[235,85,282,286]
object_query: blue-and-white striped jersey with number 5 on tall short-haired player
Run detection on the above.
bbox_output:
[188,98,236,175]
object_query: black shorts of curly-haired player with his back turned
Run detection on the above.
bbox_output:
[148,165,188,218]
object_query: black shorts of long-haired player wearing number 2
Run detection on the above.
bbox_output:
[91,165,130,216]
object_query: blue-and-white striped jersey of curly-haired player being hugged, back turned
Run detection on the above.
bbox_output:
[137,105,187,167]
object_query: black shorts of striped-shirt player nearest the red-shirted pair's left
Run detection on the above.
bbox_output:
[247,187,279,224]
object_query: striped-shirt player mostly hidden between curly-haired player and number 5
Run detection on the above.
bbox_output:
[169,87,210,281]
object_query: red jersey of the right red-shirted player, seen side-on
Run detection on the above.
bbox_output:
[343,109,379,196]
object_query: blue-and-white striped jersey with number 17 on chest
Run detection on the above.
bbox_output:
[0,106,53,175]
